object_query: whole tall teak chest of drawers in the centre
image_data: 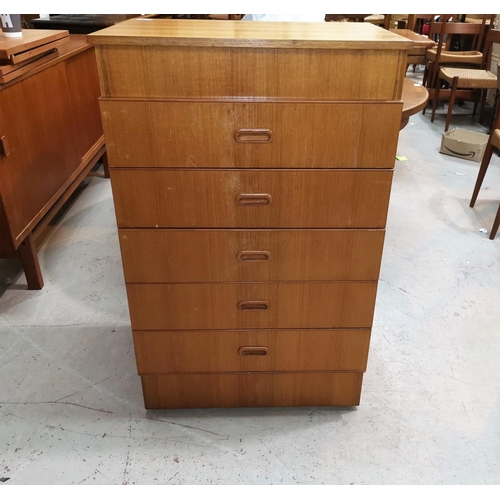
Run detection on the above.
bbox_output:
[89,19,411,408]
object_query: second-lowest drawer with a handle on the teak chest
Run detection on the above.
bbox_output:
[127,281,377,330]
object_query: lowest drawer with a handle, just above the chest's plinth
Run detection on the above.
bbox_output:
[134,330,370,375]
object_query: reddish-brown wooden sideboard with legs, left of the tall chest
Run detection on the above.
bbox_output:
[0,35,106,290]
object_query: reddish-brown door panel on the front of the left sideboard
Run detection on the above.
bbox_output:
[0,64,81,247]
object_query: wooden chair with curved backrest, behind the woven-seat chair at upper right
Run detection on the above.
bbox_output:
[423,17,485,88]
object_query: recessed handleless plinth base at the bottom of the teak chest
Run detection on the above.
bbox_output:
[142,372,363,410]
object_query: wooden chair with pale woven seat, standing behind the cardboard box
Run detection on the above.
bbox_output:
[431,25,500,132]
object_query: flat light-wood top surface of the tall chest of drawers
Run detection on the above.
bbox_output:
[89,19,412,50]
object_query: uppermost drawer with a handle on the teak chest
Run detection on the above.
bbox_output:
[101,100,402,168]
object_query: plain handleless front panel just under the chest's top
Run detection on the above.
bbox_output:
[96,45,406,101]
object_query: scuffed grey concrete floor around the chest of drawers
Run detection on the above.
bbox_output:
[0,72,500,484]
